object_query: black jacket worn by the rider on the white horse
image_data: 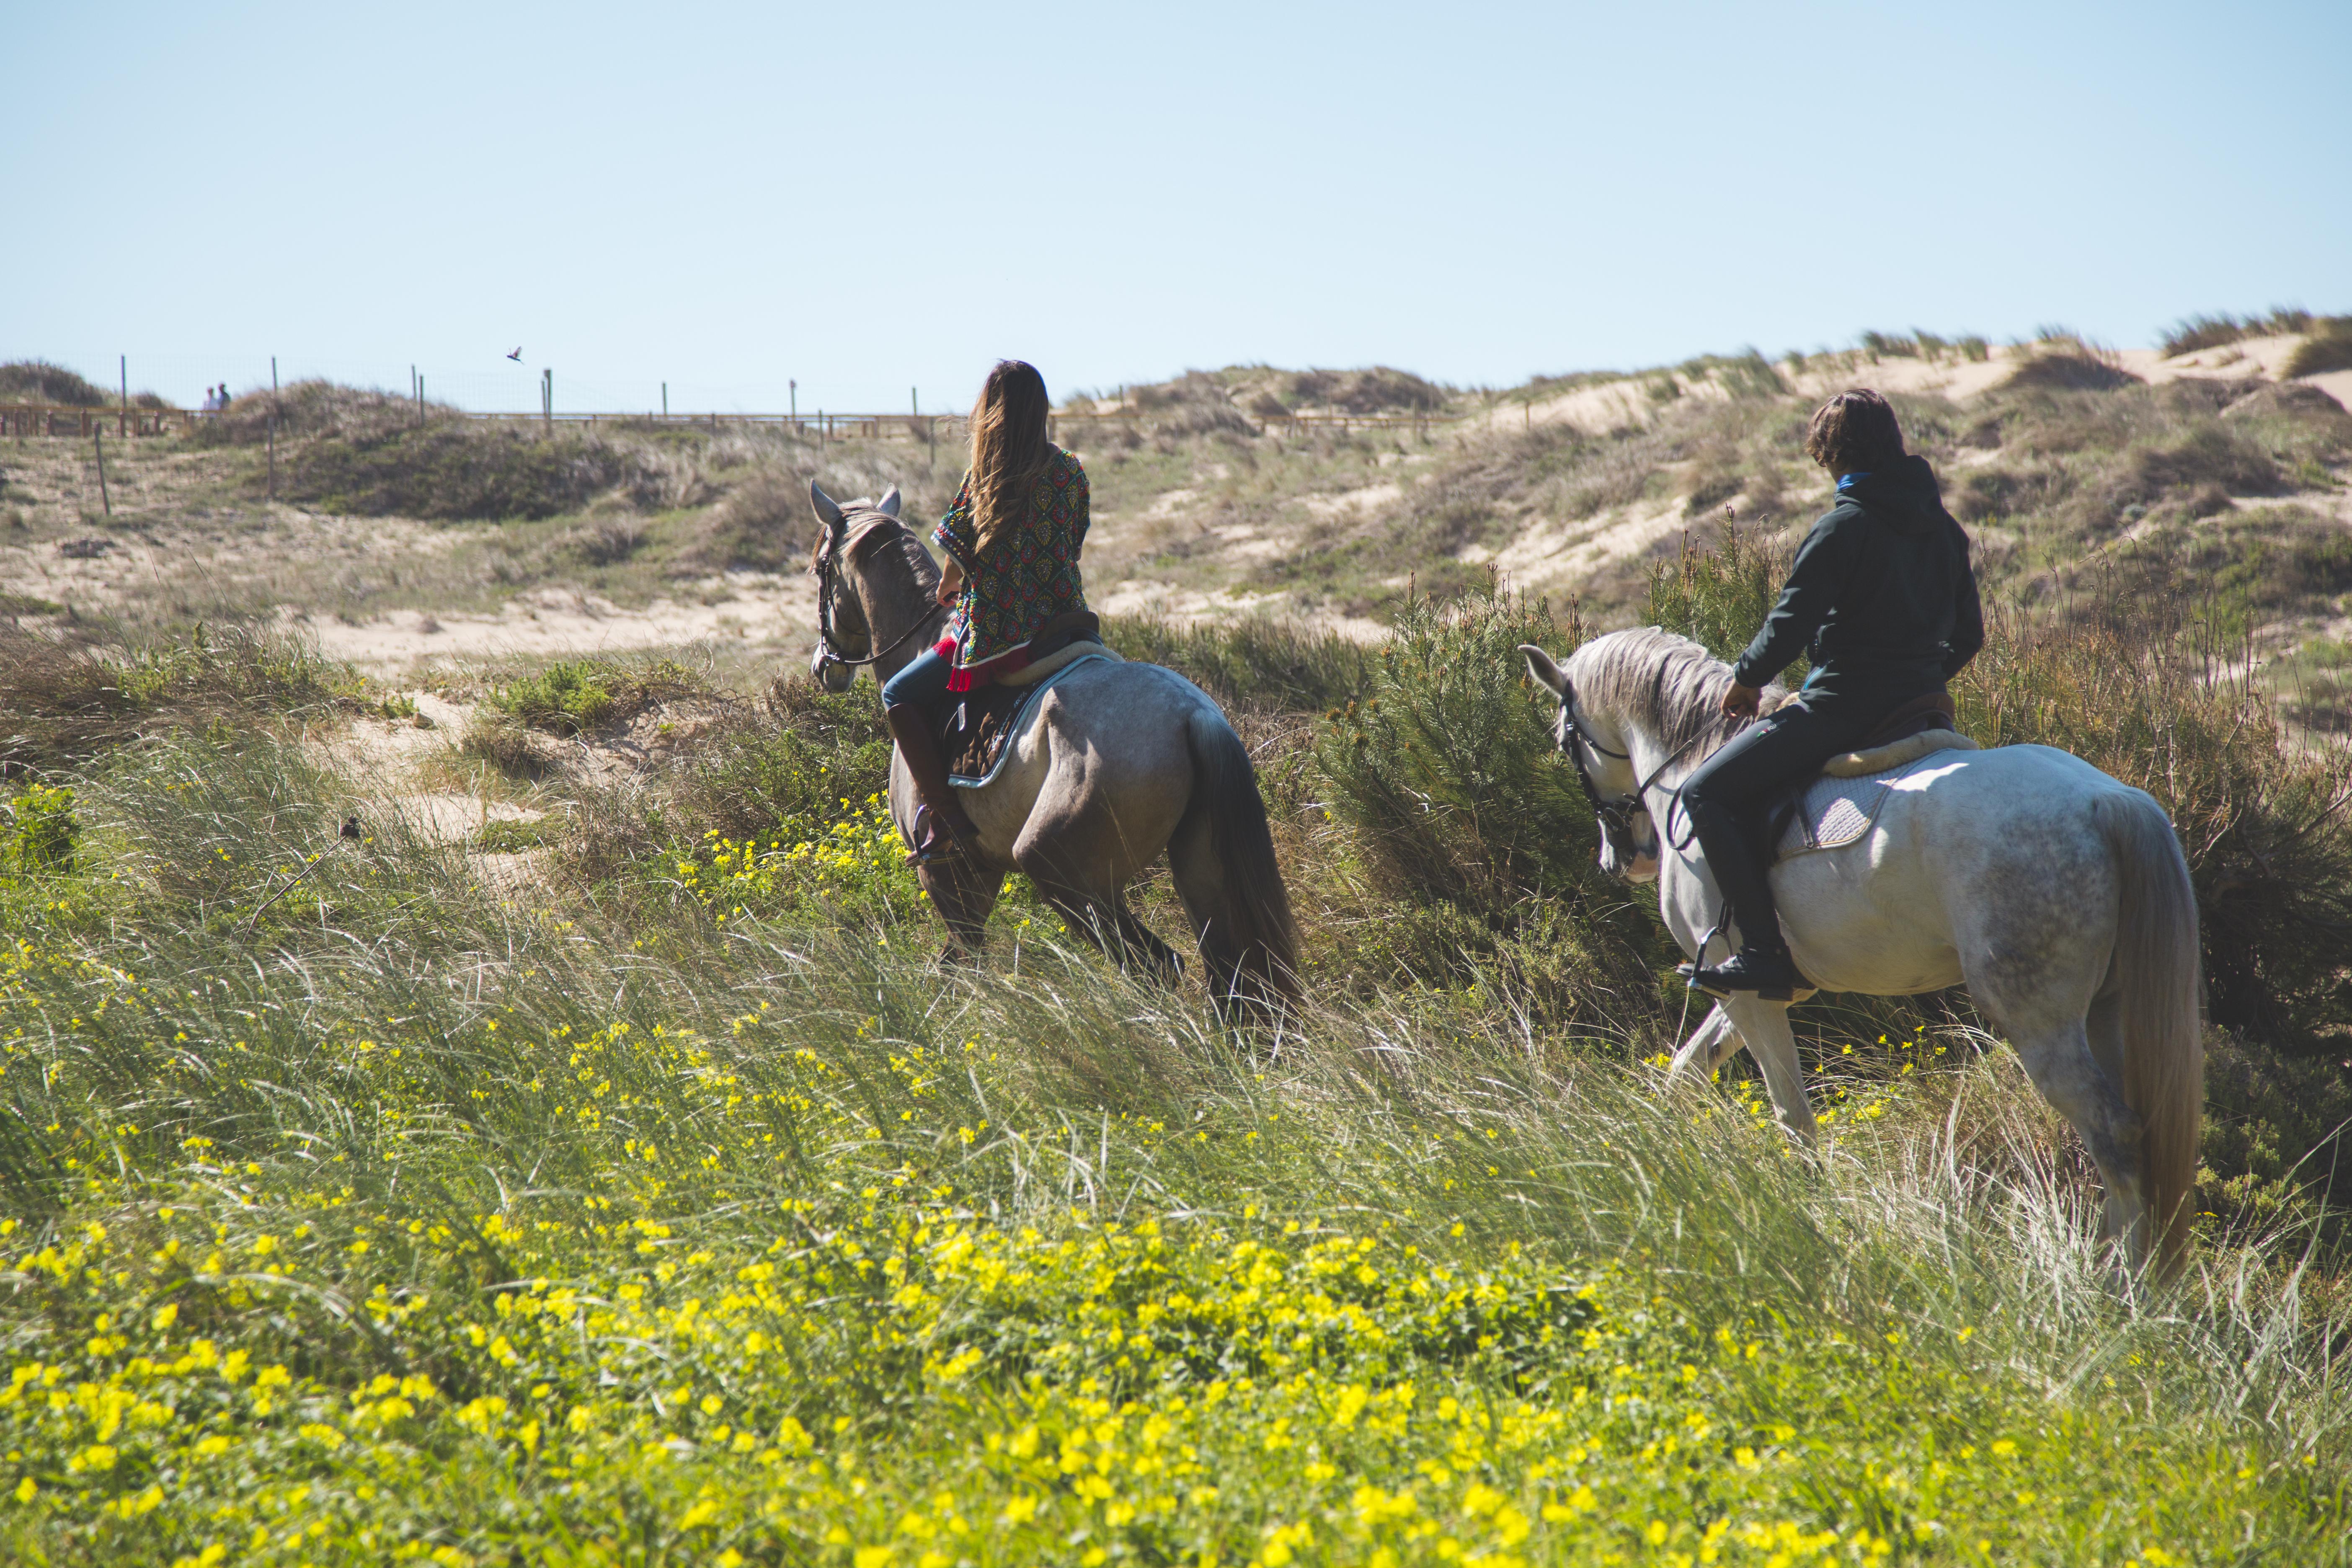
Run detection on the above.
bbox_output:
[1733,456,1985,700]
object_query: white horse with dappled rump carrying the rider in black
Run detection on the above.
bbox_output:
[1519,628,2204,1269]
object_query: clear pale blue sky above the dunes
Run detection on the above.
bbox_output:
[0,0,2352,409]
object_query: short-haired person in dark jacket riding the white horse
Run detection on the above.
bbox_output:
[1682,390,1985,1002]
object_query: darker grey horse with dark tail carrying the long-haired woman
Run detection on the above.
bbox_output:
[809,482,1298,1015]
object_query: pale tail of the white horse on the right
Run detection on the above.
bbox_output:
[2091,790,2204,1276]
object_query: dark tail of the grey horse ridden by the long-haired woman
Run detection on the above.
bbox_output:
[1169,703,1298,1011]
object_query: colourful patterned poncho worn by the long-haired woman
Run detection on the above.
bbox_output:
[932,447,1089,691]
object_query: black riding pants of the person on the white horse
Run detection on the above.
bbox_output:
[1682,691,1917,961]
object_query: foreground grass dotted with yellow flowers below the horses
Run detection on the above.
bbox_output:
[0,741,2347,1568]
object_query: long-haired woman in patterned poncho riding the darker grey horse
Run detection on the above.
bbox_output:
[882,360,1096,860]
